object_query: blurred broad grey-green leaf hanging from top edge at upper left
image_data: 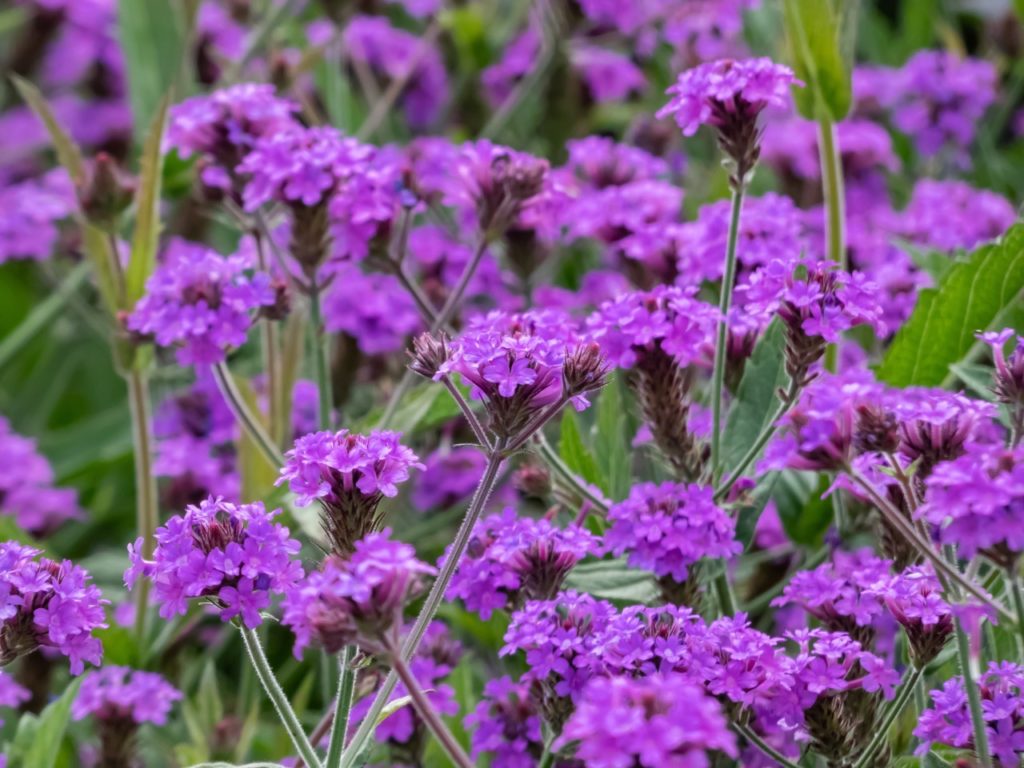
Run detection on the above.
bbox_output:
[118,0,185,137]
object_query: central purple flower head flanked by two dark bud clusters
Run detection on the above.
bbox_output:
[425,310,607,437]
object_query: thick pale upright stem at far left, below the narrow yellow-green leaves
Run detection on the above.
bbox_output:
[125,366,160,637]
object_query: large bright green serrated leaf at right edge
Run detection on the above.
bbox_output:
[878,224,1024,387]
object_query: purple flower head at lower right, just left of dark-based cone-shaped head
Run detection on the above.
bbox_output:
[772,549,892,644]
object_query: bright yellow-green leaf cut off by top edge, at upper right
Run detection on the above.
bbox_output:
[782,0,855,122]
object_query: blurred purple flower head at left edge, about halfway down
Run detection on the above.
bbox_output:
[0,416,82,537]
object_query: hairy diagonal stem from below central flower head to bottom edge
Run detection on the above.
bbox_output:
[341,441,505,768]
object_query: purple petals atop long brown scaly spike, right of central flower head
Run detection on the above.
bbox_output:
[588,286,719,368]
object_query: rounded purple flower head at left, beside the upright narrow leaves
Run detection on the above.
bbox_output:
[126,241,275,366]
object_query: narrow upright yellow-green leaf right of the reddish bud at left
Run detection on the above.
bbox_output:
[121,95,170,310]
